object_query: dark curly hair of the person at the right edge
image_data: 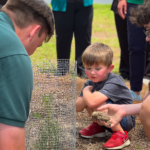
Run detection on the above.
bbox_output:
[130,0,150,27]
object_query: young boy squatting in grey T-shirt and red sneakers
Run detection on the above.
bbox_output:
[76,43,135,149]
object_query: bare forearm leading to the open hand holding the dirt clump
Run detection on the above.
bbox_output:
[121,103,142,116]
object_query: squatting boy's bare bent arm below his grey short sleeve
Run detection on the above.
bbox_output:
[83,86,108,108]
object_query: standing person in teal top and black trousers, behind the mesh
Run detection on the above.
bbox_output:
[51,0,93,78]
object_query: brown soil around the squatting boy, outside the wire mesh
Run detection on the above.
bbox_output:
[76,78,150,150]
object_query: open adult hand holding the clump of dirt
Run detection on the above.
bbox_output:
[97,104,125,128]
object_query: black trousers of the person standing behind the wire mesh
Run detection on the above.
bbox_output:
[53,2,93,74]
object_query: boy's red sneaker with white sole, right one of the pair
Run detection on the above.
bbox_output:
[104,131,130,150]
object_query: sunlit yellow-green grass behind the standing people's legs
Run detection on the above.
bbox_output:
[31,4,120,74]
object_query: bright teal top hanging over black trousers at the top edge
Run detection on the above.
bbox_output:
[51,0,93,11]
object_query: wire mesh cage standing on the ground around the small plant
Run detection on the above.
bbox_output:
[25,60,76,150]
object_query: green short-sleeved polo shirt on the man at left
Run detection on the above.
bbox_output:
[0,12,33,127]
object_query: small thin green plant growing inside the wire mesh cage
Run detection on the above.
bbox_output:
[35,94,60,150]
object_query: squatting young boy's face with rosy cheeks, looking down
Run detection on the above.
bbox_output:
[84,64,114,82]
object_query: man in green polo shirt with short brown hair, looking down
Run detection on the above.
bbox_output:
[0,0,54,150]
